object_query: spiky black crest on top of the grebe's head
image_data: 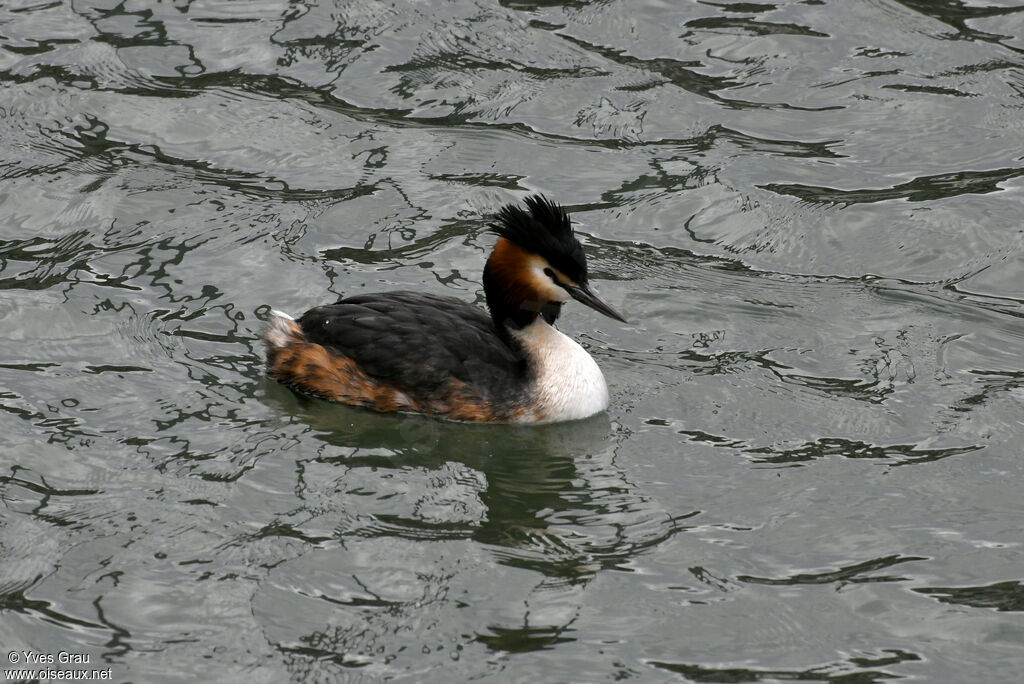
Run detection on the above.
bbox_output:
[490,195,587,285]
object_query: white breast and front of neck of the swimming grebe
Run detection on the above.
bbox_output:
[512,317,608,423]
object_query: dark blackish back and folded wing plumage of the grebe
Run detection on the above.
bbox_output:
[298,292,526,399]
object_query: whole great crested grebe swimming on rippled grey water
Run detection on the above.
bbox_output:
[264,195,626,423]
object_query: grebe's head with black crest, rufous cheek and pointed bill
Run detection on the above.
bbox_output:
[483,195,626,328]
